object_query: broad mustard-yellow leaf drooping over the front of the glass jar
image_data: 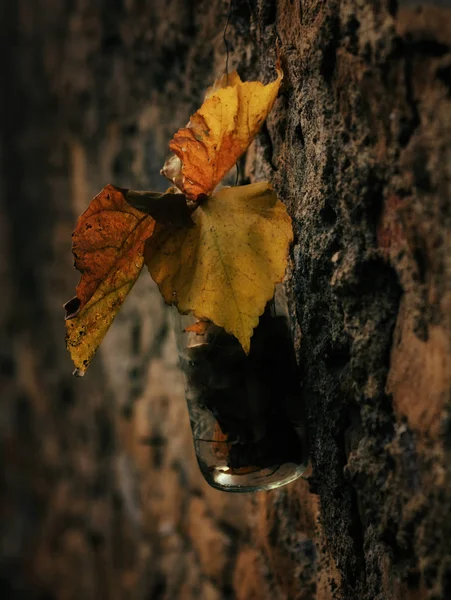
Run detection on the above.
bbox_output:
[144,182,293,353]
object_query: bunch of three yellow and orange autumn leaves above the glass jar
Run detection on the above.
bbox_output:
[65,66,293,376]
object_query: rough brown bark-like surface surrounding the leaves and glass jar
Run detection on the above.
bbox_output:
[0,0,451,600]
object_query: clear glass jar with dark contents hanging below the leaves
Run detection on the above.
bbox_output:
[173,293,308,492]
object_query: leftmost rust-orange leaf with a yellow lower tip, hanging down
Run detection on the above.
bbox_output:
[65,185,161,375]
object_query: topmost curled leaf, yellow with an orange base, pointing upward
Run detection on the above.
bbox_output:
[162,67,283,200]
